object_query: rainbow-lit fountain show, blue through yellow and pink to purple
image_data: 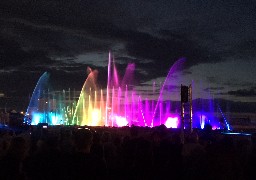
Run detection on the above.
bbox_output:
[27,53,228,128]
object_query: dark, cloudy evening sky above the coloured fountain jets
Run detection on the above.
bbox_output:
[0,0,256,105]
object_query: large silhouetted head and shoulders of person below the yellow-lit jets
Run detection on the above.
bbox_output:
[64,129,107,180]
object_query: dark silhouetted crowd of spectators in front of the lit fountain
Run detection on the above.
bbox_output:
[0,125,256,180]
